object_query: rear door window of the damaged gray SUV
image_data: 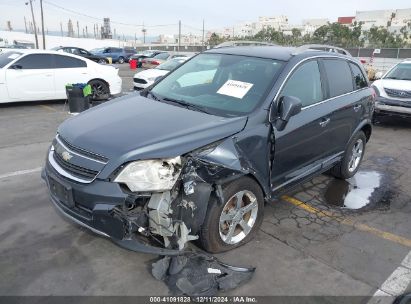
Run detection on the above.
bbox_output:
[323,59,353,97]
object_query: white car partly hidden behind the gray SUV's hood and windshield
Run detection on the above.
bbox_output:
[133,57,188,90]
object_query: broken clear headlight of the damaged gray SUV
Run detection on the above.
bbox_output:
[114,156,181,192]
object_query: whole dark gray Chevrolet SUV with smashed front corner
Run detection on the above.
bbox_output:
[42,46,374,255]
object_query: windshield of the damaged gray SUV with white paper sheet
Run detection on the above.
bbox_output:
[151,53,283,116]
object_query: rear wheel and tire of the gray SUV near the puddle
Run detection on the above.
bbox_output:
[330,131,367,179]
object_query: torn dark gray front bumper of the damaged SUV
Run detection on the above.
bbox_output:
[41,162,183,255]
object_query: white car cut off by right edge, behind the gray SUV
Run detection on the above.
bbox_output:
[372,59,411,120]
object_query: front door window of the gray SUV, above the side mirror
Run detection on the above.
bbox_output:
[281,60,324,107]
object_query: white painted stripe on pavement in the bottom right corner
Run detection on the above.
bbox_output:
[368,251,411,304]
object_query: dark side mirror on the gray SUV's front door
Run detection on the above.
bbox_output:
[270,96,302,131]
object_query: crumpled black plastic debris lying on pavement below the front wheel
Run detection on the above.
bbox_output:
[152,253,255,296]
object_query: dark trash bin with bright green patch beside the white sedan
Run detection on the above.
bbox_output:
[66,83,91,113]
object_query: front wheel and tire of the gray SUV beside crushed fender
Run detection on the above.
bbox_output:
[199,177,264,253]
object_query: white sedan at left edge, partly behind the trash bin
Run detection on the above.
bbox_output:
[0,50,122,103]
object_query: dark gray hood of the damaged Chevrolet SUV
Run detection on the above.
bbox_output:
[58,94,247,164]
